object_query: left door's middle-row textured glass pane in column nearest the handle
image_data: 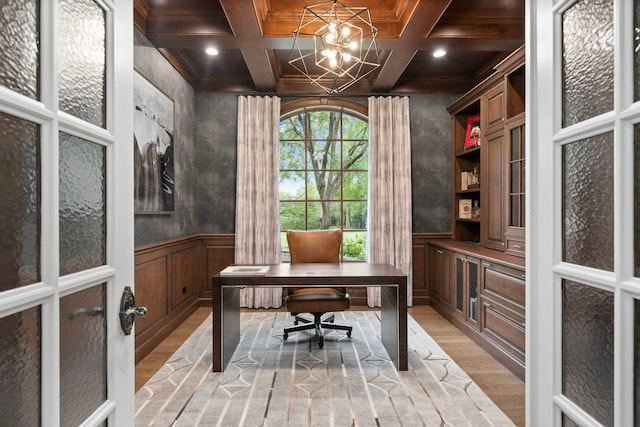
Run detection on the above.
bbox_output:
[60,133,107,275]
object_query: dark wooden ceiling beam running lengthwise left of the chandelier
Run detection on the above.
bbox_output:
[218,0,278,92]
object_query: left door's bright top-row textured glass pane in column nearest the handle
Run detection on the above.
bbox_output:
[58,0,106,127]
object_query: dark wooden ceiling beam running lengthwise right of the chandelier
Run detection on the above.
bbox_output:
[373,0,451,92]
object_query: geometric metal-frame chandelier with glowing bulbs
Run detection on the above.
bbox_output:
[289,0,380,93]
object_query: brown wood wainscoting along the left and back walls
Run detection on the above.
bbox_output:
[135,233,451,363]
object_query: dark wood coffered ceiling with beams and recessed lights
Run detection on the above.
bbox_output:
[134,0,524,94]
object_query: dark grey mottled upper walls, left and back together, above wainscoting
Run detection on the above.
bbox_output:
[134,30,458,246]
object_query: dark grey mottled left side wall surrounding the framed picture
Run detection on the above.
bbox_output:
[131,29,198,247]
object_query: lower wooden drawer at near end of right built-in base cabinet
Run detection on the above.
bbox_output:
[482,301,525,362]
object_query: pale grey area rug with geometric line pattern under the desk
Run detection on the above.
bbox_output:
[136,311,513,427]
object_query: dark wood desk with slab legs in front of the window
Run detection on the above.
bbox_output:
[213,262,407,372]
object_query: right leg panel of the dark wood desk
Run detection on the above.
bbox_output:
[380,285,408,371]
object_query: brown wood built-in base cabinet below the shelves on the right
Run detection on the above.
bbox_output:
[427,240,526,379]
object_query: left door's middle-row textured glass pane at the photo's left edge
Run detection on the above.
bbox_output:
[0,113,40,292]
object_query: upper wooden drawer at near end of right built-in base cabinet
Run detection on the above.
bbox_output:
[483,263,525,313]
